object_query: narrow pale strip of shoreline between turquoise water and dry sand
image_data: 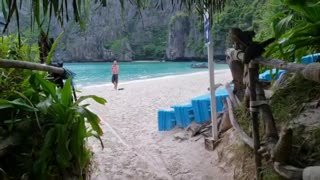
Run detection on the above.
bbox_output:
[78,69,230,90]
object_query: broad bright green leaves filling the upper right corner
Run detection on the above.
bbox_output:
[266,0,320,62]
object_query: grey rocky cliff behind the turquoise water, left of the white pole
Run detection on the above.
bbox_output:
[55,1,205,62]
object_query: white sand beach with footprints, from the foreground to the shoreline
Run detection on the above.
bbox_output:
[82,70,232,180]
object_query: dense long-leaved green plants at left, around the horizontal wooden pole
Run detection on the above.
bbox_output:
[0,37,106,179]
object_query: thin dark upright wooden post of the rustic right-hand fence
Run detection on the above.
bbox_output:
[248,62,262,180]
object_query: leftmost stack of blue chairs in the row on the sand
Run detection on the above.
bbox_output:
[158,109,176,131]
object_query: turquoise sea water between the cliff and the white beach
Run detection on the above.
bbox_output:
[64,62,228,86]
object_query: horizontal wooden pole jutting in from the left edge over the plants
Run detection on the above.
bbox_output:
[0,59,65,75]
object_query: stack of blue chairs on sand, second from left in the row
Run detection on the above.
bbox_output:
[171,104,194,128]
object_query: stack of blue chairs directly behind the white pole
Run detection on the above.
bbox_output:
[191,89,229,123]
